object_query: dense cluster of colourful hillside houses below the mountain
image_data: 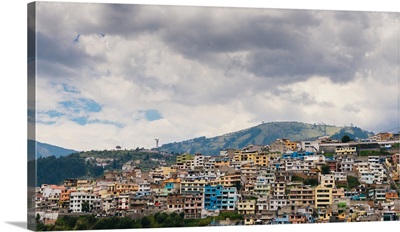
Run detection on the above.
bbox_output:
[35,133,400,225]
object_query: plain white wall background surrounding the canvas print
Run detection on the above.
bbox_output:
[0,0,400,231]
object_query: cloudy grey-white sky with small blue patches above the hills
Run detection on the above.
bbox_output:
[29,2,399,150]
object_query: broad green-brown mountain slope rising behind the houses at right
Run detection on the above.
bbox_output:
[160,122,372,155]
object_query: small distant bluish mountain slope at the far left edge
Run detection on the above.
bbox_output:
[28,139,77,160]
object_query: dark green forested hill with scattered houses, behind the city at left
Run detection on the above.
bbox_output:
[28,150,175,186]
